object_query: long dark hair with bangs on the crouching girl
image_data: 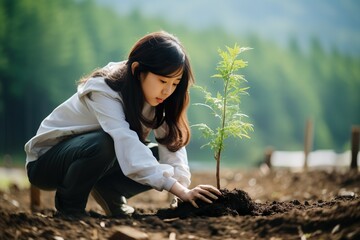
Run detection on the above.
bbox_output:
[80,31,194,152]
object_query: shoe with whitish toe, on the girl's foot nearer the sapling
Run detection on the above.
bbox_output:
[91,188,135,217]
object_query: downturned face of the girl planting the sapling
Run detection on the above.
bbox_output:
[140,71,182,106]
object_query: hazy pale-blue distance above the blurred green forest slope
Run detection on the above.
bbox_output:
[96,0,360,56]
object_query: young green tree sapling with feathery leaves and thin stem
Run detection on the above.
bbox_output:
[193,44,253,189]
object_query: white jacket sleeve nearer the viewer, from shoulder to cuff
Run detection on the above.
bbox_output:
[79,91,176,191]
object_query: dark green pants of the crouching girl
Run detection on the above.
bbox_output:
[27,131,158,212]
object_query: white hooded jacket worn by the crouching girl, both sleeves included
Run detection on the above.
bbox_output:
[25,68,191,190]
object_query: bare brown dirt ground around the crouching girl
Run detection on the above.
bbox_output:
[0,166,360,240]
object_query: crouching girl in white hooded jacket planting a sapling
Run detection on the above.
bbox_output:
[25,32,221,216]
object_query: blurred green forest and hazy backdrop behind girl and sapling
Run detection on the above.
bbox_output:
[0,0,360,167]
